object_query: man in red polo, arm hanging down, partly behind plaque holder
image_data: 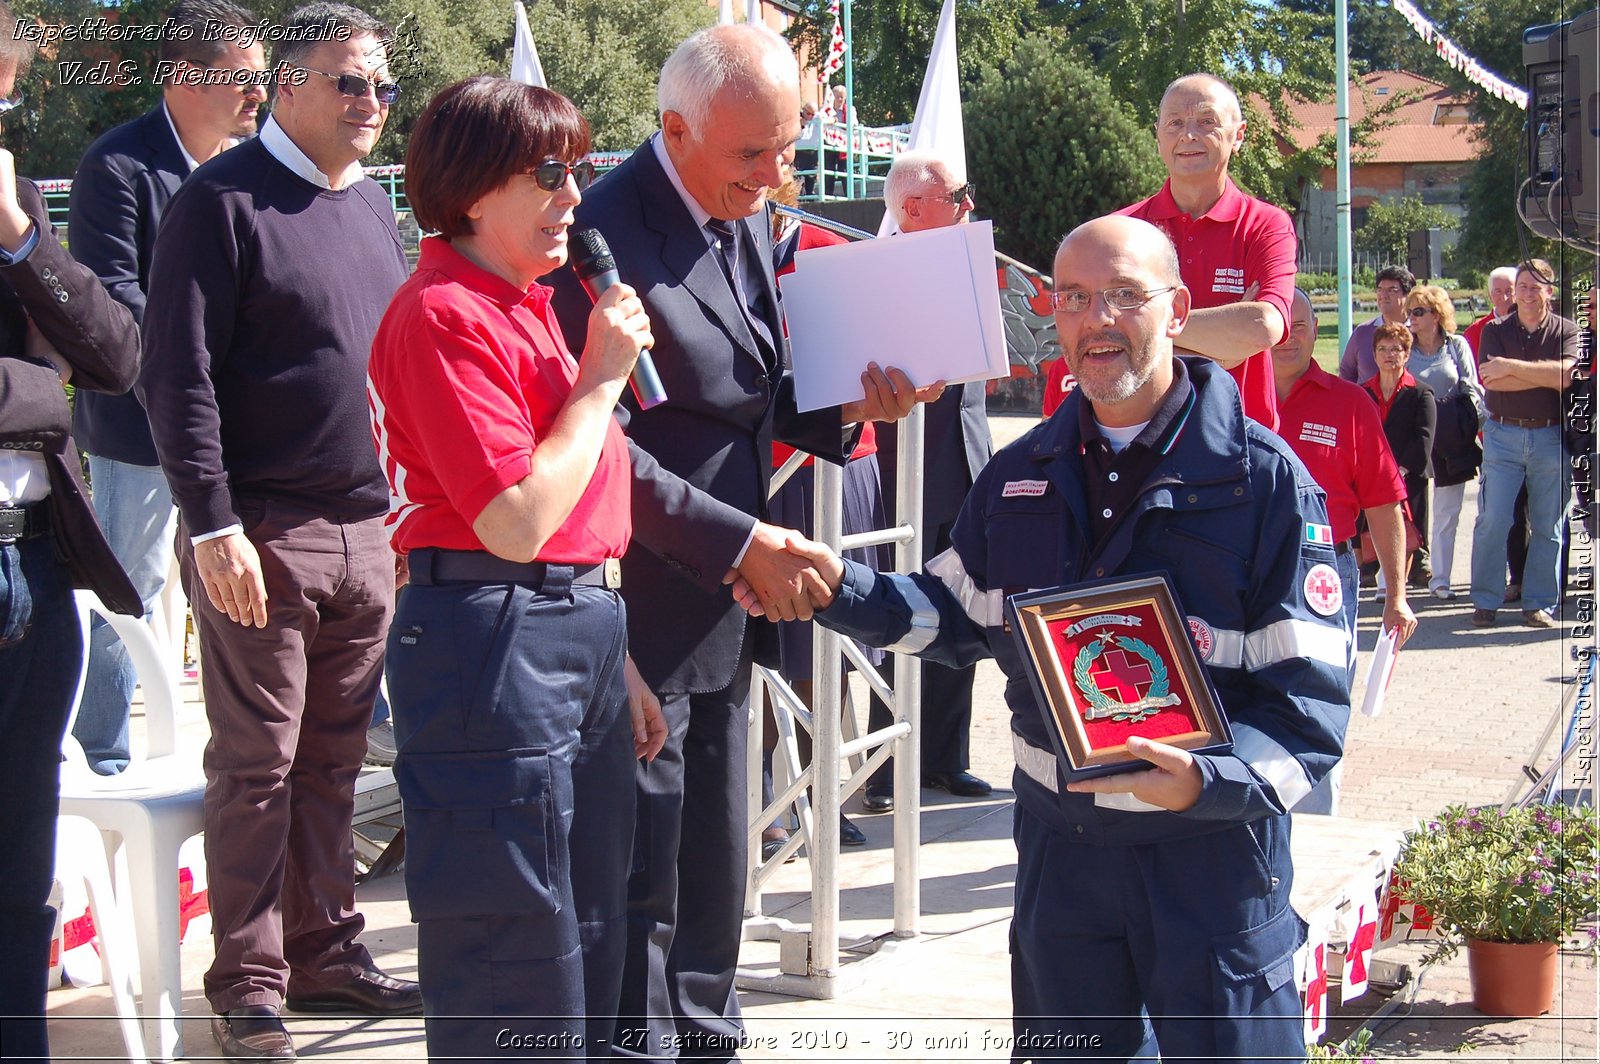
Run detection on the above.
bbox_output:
[1272,288,1416,813]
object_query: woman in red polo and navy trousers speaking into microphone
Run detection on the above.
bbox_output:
[368,77,666,1058]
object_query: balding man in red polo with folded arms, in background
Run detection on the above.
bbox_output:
[1117,74,1296,429]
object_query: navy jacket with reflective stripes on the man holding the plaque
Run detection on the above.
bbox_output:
[818,358,1350,845]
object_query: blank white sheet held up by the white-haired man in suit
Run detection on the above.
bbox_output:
[779,222,1010,411]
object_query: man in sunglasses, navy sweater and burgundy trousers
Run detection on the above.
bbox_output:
[139,3,422,1061]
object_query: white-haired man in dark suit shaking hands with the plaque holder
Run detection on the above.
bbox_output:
[552,24,933,1059]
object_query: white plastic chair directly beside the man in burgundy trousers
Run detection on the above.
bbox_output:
[61,590,205,1061]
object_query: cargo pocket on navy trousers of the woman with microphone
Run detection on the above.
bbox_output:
[395,749,570,928]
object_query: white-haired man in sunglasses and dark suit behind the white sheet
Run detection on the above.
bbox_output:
[862,150,995,813]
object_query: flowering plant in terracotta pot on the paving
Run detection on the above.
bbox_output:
[1395,805,1600,1016]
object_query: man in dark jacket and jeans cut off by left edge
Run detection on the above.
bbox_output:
[0,8,139,1061]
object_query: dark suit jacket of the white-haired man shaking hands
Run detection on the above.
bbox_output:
[546,141,856,694]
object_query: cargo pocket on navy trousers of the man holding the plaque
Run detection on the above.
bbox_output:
[1211,906,1306,1059]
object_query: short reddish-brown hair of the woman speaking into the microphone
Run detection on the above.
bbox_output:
[405,75,592,237]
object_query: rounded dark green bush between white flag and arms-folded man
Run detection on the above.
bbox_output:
[965,30,1163,274]
